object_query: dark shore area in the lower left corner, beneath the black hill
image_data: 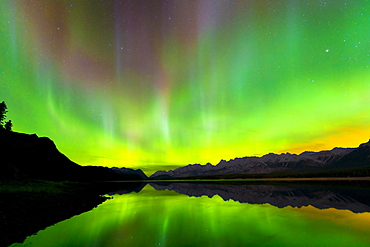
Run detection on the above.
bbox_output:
[0,180,109,246]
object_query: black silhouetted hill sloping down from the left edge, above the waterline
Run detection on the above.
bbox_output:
[0,132,147,181]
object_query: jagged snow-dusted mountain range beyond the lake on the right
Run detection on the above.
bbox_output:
[150,142,370,180]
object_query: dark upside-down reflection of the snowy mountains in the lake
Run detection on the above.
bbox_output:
[150,182,370,213]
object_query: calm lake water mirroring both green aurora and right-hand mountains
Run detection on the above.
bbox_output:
[12,183,370,247]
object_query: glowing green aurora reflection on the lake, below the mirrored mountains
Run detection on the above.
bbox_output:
[12,185,370,247]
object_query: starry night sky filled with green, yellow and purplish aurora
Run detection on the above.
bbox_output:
[0,0,370,175]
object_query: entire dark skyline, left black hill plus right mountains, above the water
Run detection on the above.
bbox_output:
[0,132,370,181]
